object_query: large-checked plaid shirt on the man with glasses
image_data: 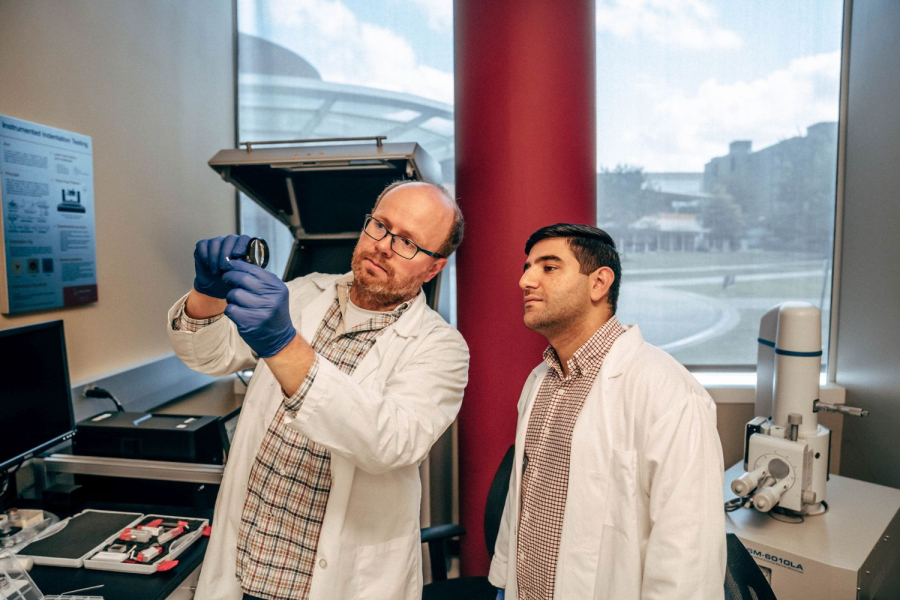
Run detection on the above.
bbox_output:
[173,283,411,600]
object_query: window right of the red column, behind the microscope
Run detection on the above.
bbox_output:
[596,0,843,366]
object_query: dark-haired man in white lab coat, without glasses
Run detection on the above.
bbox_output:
[490,223,725,600]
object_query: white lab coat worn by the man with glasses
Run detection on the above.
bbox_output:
[169,274,468,600]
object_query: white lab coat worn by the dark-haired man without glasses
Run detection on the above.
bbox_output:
[490,326,725,600]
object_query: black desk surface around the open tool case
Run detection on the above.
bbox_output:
[29,504,212,600]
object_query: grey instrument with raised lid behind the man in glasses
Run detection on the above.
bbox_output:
[209,136,450,308]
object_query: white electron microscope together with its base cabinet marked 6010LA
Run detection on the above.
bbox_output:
[723,302,900,600]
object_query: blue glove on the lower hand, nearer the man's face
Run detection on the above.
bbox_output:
[222,260,297,358]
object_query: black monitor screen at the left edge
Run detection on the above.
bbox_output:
[0,321,75,470]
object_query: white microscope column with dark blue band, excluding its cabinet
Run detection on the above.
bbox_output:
[731,302,868,515]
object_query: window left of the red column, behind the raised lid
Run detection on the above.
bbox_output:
[237,0,455,322]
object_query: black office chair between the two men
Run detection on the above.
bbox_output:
[422,446,512,600]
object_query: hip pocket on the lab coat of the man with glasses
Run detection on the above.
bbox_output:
[356,531,422,600]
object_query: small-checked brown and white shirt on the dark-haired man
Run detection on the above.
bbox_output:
[516,317,625,600]
